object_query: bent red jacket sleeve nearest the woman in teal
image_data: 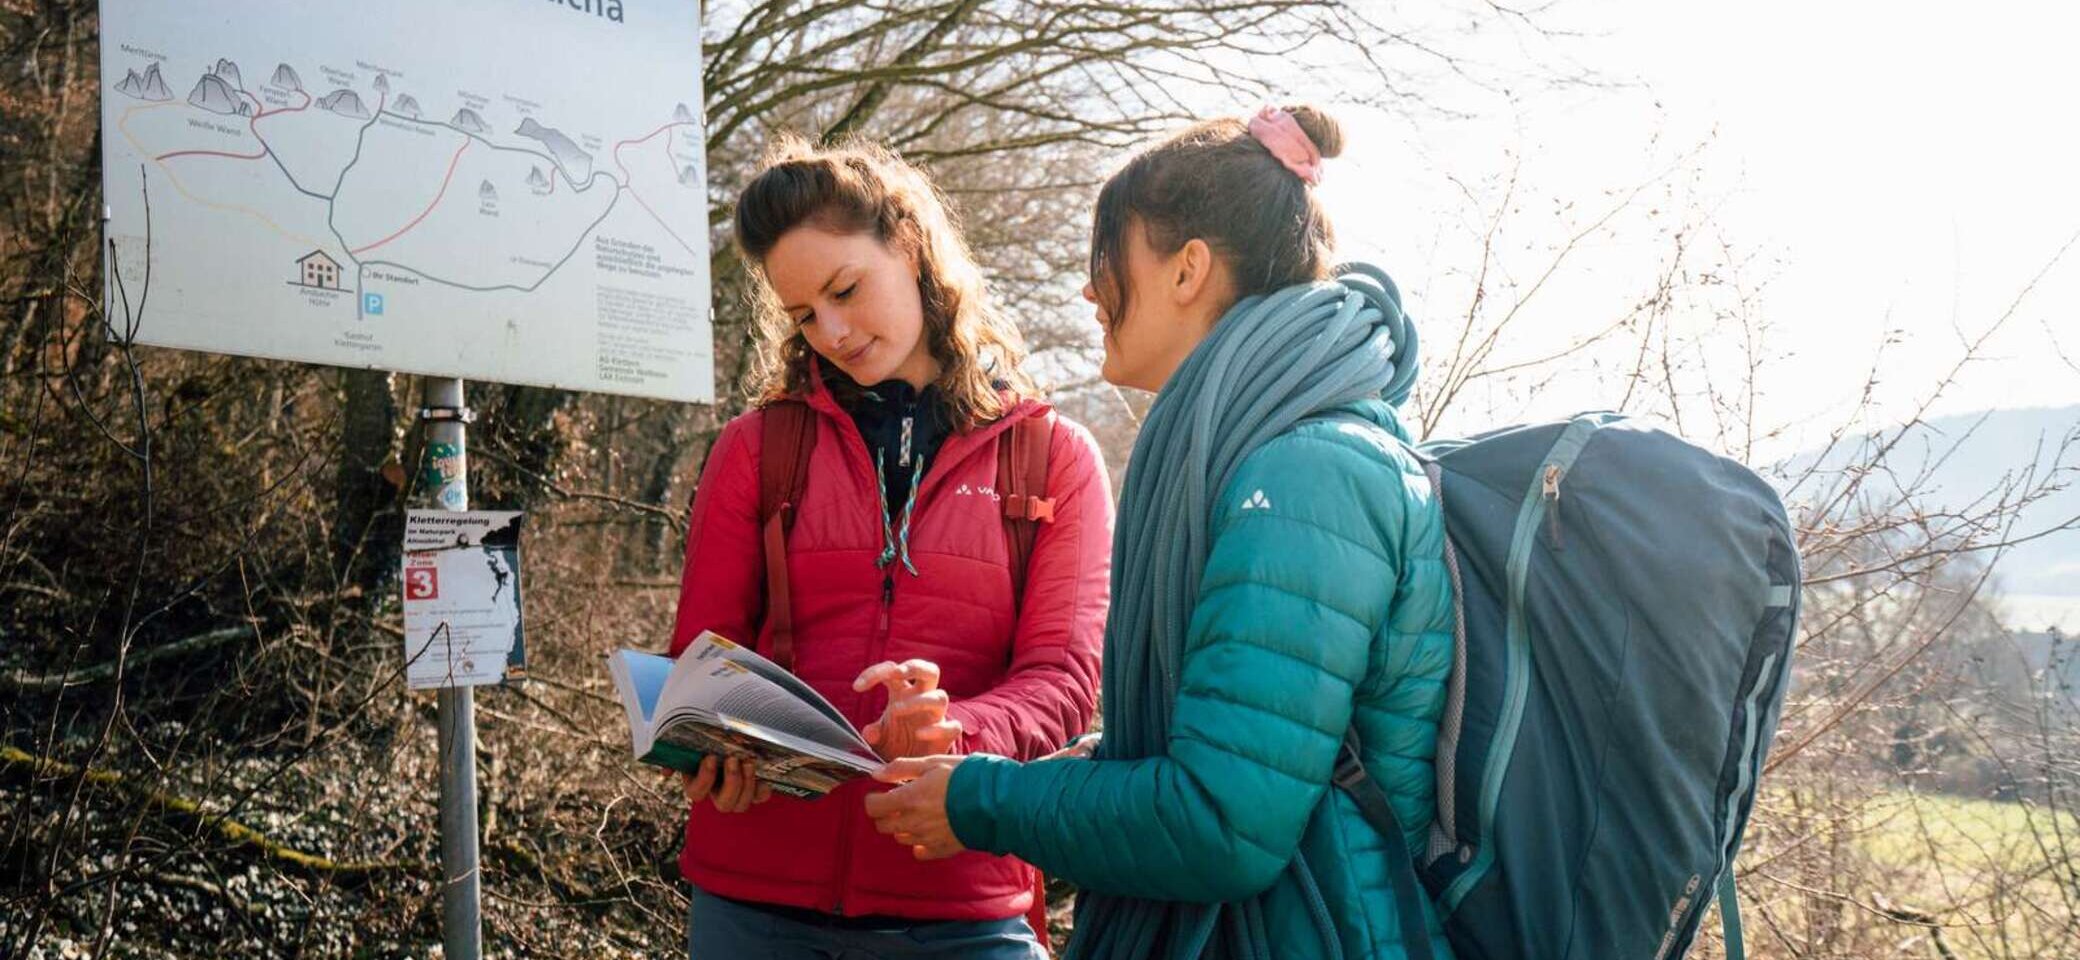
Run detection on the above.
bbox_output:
[946,420,1113,761]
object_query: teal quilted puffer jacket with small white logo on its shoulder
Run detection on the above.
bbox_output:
[946,392,1452,960]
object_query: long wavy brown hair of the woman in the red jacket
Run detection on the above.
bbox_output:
[736,135,1038,430]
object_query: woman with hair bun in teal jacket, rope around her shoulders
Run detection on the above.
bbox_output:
[867,106,1454,960]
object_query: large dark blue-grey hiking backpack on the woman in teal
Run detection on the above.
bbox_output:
[1335,414,1799,960]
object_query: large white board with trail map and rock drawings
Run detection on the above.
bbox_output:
[102,0,713,401]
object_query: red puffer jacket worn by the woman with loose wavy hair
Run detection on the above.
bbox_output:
[672,376,1113,921]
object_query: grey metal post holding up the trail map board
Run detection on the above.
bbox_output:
[418,376,485,960]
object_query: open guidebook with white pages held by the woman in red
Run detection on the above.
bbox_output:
[607,632,884,798]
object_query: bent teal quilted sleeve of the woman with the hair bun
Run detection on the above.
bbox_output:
[946,428,1408,902]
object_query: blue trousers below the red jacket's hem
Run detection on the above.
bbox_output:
[686,889,1046,960]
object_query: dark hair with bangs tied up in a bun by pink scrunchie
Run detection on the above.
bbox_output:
[1090,104,1344,324]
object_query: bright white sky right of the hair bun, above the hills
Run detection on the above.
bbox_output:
[1315,0,2080,453]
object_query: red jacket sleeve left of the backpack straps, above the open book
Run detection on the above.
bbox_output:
[672,411,765,657]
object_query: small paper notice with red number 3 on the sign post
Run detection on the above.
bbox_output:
[404,509,526,690]
